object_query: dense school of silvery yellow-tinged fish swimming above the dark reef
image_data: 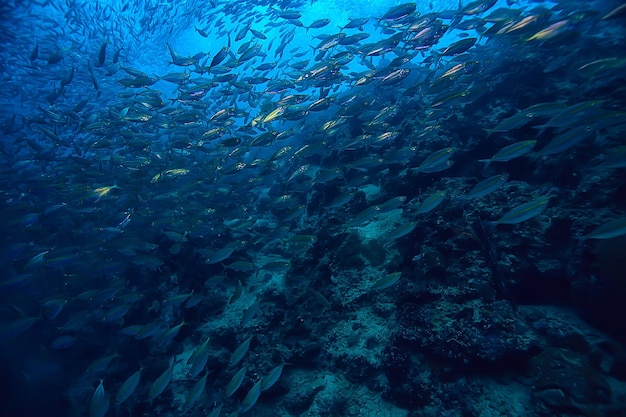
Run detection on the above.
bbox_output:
[0,0,626,417]
